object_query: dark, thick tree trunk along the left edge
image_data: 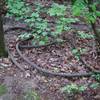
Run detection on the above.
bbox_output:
[0,0,8,57]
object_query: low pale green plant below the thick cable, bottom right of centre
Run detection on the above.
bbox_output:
[61,83,87,94]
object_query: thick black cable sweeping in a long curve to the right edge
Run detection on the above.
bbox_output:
[16,42,100,77]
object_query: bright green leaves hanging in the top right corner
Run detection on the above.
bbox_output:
[72,0,100,23]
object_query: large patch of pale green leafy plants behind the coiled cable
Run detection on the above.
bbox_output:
[7,0,79,45]
